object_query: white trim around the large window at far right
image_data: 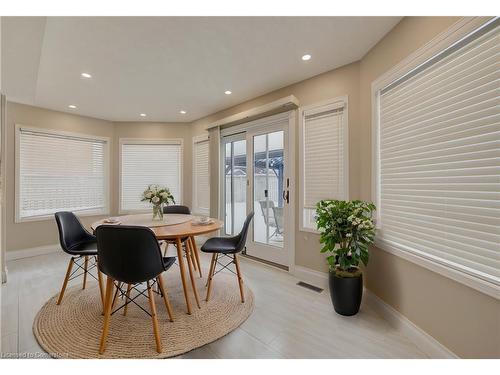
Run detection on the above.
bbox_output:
[371,17,500,299]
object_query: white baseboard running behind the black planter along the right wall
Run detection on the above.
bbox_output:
[293,265,458,358]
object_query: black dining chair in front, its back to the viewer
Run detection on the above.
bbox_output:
[95,225,175,354]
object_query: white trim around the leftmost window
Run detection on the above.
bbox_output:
[14,124,110,224]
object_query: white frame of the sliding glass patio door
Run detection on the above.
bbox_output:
[219,110,297,273]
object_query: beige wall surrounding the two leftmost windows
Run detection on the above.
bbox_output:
[6,102,192,251]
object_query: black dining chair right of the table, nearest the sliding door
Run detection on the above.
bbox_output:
[201,212,253,303]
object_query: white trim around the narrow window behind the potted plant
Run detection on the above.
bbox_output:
[299,95,349,234]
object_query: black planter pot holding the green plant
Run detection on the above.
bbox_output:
[329,272,363,316]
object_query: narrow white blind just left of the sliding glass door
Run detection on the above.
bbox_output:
[193,139,210,215]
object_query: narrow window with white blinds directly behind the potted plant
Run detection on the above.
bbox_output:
[301,100,348,230]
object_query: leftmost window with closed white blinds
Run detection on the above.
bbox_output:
[16,127,108,221]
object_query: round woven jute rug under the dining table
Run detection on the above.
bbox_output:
[33,271,254,358]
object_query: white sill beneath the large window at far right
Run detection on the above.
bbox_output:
[374,240,500,300]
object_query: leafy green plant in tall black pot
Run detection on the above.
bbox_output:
[316,200,375,315]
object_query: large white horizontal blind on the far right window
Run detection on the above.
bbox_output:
[377,21,500,285]
